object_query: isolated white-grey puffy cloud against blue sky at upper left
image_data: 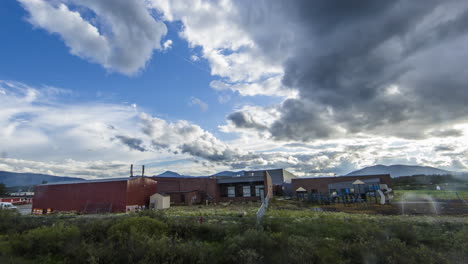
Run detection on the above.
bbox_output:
[18,0,170,75]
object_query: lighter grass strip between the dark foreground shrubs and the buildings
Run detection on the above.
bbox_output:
[133,198,468,221]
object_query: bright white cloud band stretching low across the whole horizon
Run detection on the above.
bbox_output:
[0,81,468,178]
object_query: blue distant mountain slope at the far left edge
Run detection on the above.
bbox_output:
[0,171,85,187]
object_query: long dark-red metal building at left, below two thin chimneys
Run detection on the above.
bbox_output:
[33,177,157,213]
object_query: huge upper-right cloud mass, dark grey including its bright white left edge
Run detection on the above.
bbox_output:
[152,0,468,142]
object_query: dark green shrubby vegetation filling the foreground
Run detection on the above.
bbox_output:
[0,207,468,264]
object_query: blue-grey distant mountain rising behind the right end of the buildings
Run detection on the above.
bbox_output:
[346,165,456,178]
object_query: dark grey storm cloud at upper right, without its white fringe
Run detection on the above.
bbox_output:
[231,0,468,141]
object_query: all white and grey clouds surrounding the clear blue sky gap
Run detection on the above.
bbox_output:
[9,0,468,177]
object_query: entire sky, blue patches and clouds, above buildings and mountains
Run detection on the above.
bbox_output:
[0,0,468,179]
